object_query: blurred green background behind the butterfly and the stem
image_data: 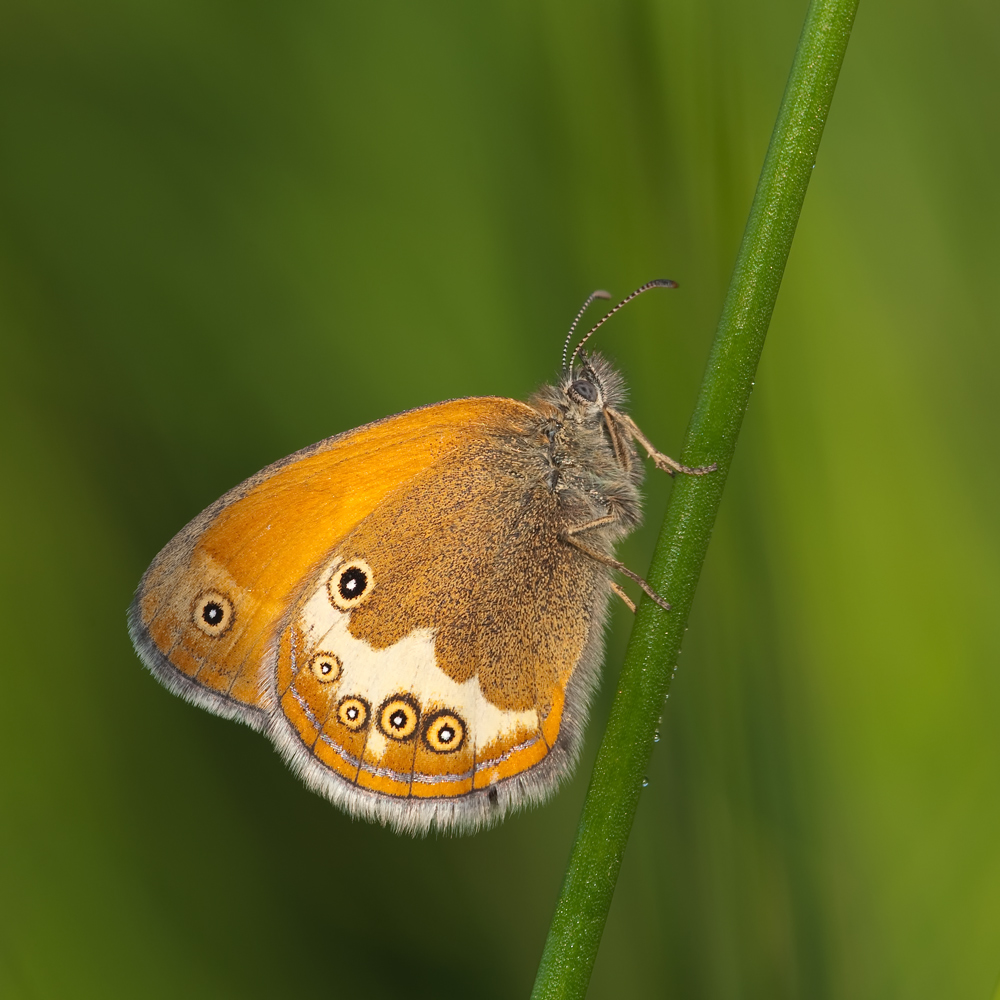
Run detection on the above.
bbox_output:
[0,0,1000,1000]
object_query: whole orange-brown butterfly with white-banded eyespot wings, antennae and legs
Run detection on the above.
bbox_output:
[128,279,714,834]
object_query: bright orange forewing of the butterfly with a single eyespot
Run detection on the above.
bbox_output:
[129,398,528,728]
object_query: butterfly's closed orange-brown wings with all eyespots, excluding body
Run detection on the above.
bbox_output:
[129,398,605,830]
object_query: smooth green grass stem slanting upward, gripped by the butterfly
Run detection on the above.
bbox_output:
[532,0,857,1000]
